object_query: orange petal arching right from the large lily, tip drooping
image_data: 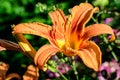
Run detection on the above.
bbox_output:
[83,24,115,41]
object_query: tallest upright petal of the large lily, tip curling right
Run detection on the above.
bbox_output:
[66,3,99,48]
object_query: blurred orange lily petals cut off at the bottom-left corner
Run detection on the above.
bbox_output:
[0,62,39,80]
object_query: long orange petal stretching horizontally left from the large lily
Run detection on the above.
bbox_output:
[13,22,52,38]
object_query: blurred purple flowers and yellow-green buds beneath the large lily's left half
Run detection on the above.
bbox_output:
[46,55,71,78]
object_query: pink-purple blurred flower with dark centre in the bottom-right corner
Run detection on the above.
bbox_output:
[98,59,120,80]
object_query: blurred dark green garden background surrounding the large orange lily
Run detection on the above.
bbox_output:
[0,0,120,80]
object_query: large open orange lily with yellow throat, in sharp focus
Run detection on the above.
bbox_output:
[13,3,115,71]
